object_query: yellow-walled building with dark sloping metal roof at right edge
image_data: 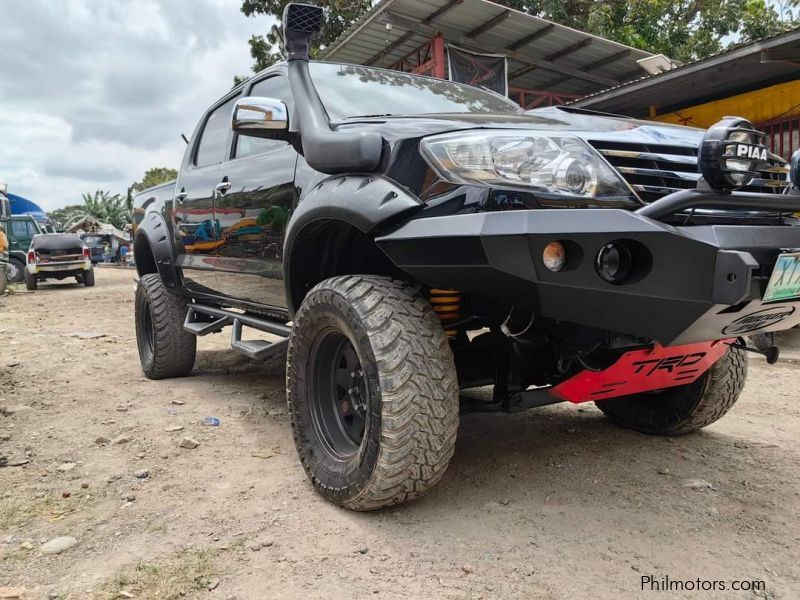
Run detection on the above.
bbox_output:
[571,29,800,159]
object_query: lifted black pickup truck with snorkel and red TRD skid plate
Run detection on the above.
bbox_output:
[134,4,800,510]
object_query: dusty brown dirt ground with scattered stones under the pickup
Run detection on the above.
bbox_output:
[0,268,800,599]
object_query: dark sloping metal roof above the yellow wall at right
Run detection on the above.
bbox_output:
[571,28,800,117]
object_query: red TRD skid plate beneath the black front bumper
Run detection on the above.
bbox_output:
[550,340,731,404]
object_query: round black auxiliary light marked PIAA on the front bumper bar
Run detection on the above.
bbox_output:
[698,117,768,190]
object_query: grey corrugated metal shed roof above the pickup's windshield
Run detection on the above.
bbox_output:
[321,0,651,95]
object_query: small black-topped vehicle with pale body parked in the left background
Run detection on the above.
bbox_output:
[25,233,94,290]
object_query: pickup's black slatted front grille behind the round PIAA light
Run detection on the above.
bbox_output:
[589,140,789,202]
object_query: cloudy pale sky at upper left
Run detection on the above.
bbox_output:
[0,0,272,211]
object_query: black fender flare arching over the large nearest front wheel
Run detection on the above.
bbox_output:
[283,174,423,315]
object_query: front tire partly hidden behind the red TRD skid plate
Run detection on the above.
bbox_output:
[595,348,747,435]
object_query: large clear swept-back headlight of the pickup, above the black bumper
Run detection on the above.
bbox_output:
[420,129,631,198]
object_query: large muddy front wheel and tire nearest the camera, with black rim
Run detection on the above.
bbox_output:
[286,275,459,510]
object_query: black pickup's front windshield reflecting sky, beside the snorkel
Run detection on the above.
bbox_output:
[311,63,522,119]
